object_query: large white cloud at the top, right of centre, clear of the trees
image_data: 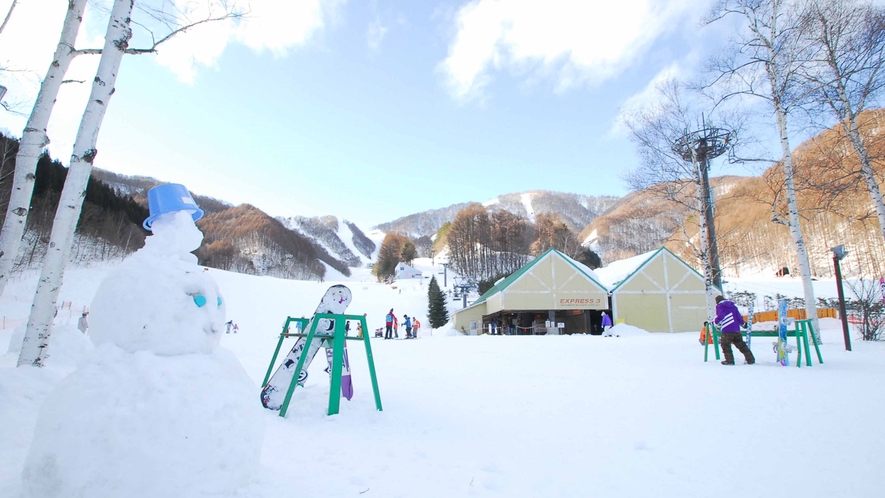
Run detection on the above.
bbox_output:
[438,0,709,100]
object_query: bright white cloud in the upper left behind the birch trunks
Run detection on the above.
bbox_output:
[0,0,345,162]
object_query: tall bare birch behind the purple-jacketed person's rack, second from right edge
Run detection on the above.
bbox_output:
[710,0,820,342]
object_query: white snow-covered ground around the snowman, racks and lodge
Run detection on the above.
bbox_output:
[0,262,885,498]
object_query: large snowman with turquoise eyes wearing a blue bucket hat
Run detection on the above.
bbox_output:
[22,184,264,497]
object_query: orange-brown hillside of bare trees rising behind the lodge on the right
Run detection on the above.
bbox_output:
[580,110,885,277]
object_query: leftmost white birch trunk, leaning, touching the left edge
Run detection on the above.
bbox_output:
[0,0,86,296]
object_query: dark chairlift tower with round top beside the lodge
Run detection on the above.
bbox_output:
[673,116,732,290]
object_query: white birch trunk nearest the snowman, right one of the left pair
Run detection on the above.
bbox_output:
[18,0,133,367]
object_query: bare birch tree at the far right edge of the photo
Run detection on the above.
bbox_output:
[802,0,885,245]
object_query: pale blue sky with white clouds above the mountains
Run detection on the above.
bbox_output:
[0,0,746,229]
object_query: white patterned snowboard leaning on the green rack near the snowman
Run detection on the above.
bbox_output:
[261,285,351,410]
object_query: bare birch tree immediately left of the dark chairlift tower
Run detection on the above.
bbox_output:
[625,80,717,321]
